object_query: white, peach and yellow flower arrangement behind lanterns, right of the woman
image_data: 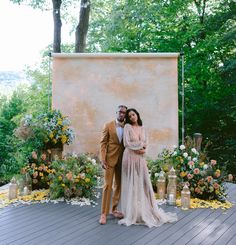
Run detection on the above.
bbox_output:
[149,145,226,200]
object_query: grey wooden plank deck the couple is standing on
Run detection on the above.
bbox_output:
[0,184,236,245]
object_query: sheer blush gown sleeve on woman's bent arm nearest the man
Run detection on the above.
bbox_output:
[124,124,144,150]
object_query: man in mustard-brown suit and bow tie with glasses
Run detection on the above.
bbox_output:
[99,105,127,225]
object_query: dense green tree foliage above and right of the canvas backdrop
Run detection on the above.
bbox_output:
[88,0,236,175]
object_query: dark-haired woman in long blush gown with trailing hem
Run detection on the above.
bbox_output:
[119,109,177,227]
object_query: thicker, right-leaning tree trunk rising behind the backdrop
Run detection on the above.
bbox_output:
[75,0,90,53]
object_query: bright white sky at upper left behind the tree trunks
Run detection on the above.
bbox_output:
[0,0,73,71]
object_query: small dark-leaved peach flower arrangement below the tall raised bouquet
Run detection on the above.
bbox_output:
[21,152,53,190]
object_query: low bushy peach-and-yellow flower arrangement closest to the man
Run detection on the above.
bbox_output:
[49,154,100,199]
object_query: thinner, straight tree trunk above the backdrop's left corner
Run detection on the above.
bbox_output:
[52,0,62,53]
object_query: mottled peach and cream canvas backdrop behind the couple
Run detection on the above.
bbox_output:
[52,53,178,158]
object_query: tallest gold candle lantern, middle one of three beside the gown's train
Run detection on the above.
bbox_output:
[167,167,177,205]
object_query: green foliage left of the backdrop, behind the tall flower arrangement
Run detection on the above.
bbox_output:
[0,58,49,183]
